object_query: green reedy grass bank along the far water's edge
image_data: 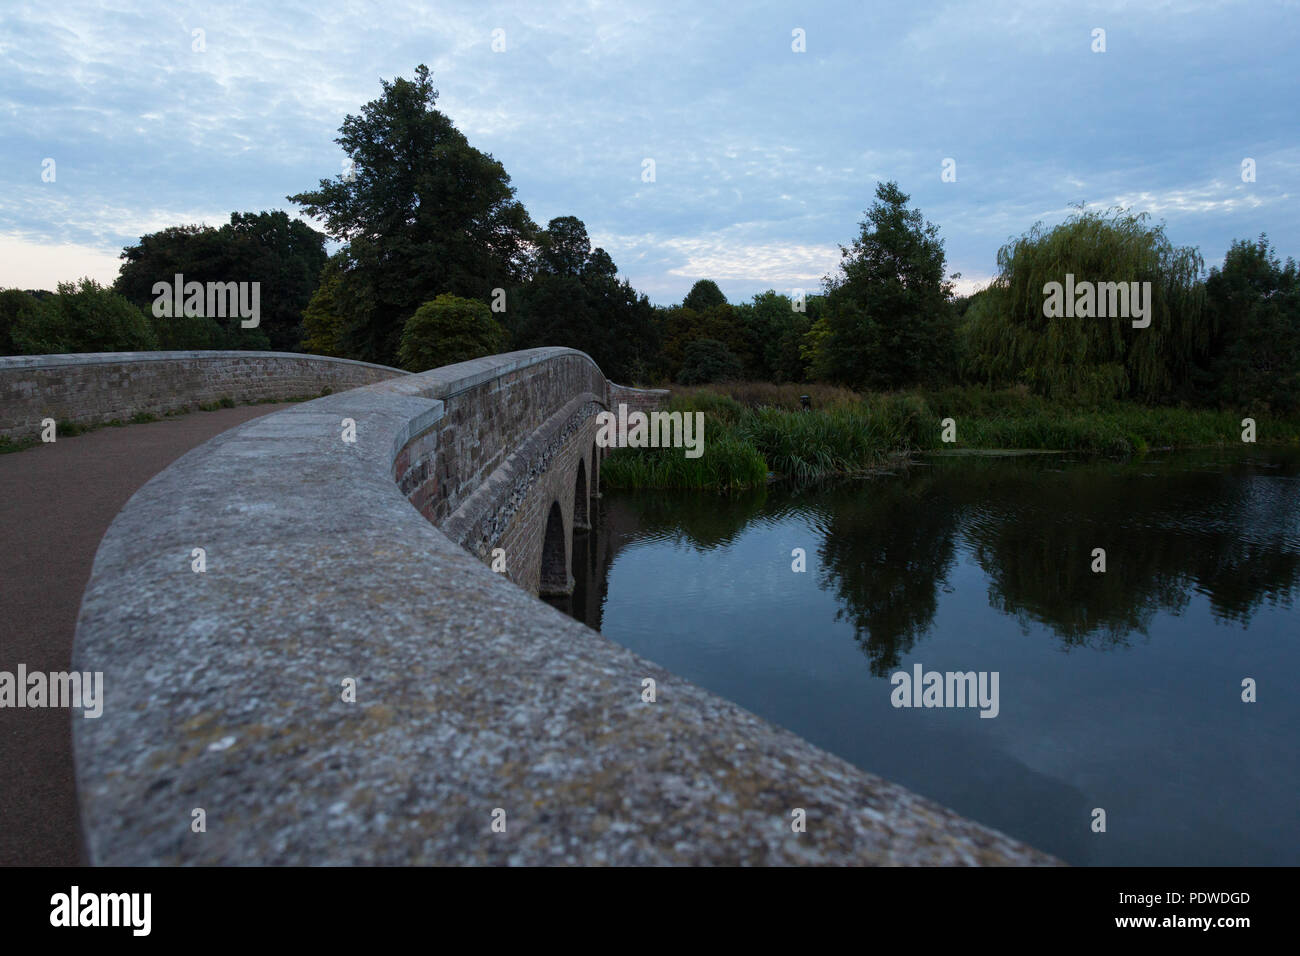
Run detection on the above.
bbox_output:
[601,382,1300,490]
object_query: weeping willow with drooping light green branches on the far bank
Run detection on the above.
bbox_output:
[962,209,1210,402]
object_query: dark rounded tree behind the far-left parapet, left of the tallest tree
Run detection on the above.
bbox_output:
[113,209,326,351]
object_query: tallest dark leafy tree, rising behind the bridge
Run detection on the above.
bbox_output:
[290,64,536,363]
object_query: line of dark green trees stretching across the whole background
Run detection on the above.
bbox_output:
[0,65,1300,411]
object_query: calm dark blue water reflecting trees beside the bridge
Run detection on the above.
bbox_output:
[553,450,1300,865]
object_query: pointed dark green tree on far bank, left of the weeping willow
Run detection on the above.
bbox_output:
[807,182,953,389]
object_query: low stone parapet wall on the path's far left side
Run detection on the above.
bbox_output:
[0,351,407,438]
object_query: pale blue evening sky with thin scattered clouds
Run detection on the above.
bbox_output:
[0,0,1300,304]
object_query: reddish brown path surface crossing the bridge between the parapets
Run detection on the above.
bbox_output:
[0,405,285,866]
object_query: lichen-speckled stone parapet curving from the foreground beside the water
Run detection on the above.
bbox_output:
[73,349,1053,865]
